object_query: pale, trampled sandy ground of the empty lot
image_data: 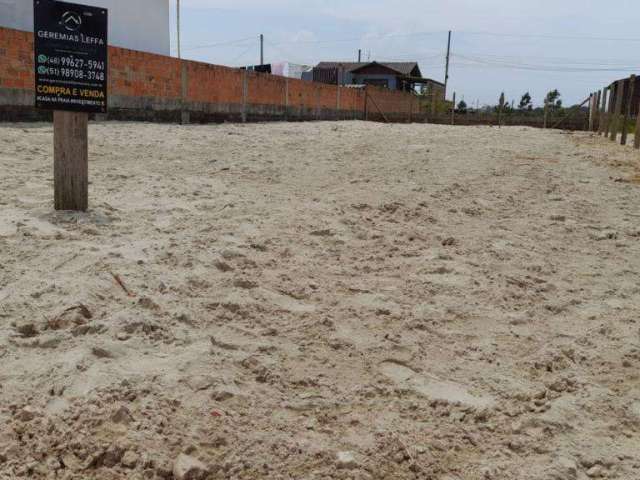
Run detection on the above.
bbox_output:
[0,122,640,480]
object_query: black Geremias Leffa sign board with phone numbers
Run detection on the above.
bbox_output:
[33,0,108,113]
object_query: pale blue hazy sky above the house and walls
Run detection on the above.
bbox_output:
[170,0,640,106]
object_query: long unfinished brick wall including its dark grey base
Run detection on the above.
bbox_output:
[0,28,412,122]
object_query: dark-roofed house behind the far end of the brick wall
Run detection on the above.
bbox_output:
[303,62,444,98]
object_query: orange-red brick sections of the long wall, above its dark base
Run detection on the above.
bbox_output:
[0,28,412,121]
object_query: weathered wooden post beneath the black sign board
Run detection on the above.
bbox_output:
[53,110,89,212]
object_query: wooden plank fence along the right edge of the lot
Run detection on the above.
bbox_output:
[589,75,640,149]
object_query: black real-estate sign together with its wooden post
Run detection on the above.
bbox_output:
[33,0,108,211]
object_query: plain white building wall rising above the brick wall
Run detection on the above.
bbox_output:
[0,0,171,55]
